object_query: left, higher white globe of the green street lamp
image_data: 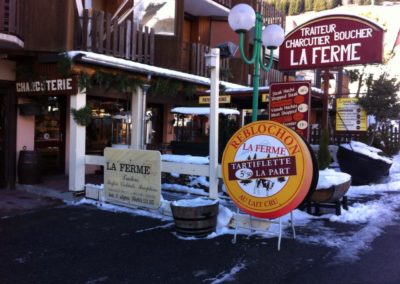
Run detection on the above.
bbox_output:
[228,4,256,33]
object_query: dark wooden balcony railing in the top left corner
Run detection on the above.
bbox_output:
[0,0,21,37]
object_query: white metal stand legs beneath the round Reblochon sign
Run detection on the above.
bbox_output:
[232,208,296,251]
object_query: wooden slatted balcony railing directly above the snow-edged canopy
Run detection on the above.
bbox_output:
[75,10,155,65]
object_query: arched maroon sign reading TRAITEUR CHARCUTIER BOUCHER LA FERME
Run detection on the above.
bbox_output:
[279,15,384,70]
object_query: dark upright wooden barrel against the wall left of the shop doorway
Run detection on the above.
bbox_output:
[18,150,41,184]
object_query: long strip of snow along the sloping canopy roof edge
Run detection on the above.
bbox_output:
[66,51,243,88]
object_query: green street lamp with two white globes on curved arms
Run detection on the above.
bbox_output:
[228,4,285,121]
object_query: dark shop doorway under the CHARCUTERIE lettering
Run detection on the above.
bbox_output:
[35,96,66,175]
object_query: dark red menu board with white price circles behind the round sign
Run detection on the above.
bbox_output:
[269,81,311,140]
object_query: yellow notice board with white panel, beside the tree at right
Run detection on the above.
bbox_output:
[336,98,368,132]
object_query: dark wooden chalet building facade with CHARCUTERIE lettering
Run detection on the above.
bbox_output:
[0,0,284,190]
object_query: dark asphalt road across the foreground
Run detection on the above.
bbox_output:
[0,204,400,284]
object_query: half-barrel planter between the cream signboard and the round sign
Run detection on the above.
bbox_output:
[171,202,219,237]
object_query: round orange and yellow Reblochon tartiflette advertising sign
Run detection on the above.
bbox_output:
[222,120,314,218]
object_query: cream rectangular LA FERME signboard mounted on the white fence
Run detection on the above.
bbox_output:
[104,148,161,209]
